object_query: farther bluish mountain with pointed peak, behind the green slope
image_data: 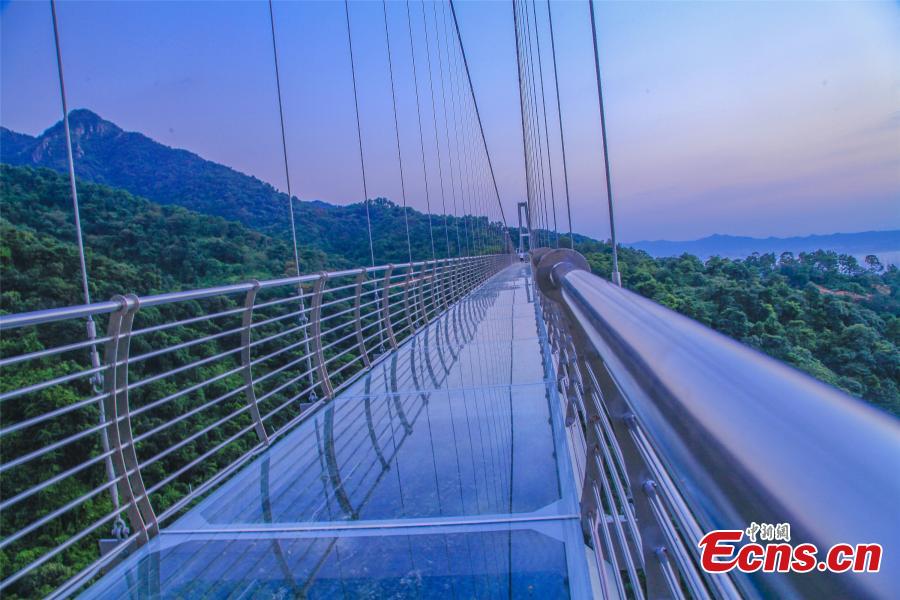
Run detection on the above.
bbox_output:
[0,109,500,265]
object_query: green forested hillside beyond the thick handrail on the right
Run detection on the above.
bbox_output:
[578,243,900,416]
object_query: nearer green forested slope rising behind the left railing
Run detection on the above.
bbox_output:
[0,165,330,312]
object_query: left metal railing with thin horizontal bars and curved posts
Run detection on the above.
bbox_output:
[0,255,511,596]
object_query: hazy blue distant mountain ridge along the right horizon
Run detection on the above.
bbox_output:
[626,230,900,260]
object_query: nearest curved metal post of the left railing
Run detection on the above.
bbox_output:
[103,294,159,545]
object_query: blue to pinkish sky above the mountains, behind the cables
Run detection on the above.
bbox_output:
[0,0,900,241]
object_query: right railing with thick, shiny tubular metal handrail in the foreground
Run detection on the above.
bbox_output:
[533,250,900,598]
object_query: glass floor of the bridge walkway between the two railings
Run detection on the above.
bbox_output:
[86,265,590,598]
